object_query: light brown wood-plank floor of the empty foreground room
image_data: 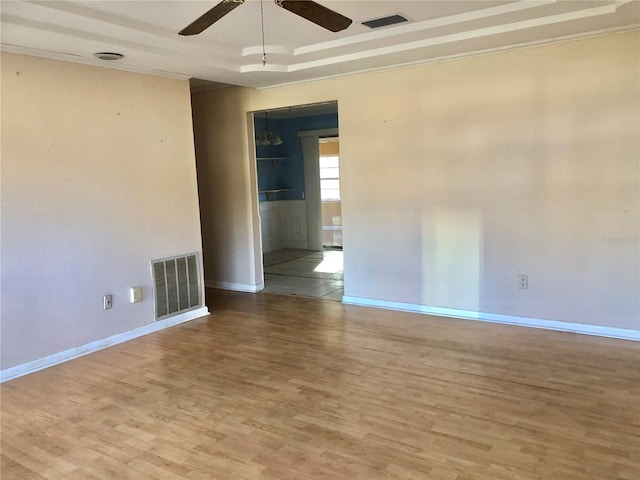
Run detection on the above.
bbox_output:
[1,291,640,480]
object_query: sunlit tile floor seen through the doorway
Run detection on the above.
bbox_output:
[263,248,344,302]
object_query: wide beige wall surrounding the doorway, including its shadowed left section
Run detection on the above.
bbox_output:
[194,32,640,329]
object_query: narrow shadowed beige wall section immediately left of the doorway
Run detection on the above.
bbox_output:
[192,88,262,290]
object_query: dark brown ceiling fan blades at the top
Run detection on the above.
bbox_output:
[179,0,351,36]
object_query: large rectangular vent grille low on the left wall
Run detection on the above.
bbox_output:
[151,253,201,320]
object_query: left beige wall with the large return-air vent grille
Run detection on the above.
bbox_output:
[1,54,201,369]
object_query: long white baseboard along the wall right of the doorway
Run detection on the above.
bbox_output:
[342,296,640,341]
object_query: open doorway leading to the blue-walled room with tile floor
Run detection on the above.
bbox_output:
[253,102,344,301]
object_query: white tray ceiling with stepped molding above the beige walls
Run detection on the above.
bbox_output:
[0,0,640,88]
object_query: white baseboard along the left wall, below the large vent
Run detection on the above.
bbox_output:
[0,307,209,383]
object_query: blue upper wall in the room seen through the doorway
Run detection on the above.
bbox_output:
[254,113,338,202]
